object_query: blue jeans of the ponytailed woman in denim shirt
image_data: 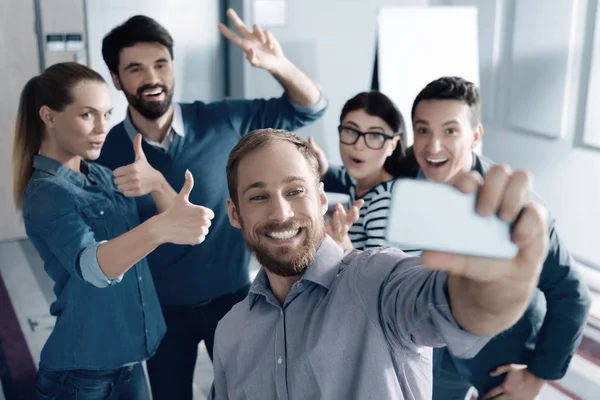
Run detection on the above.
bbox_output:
[35,363,150,400]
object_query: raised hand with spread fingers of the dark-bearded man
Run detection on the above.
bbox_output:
[219,8,287,72]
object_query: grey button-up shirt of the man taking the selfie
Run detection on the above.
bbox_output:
[210,237,490,400]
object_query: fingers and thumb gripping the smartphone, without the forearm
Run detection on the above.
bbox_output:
[421,166,548,286]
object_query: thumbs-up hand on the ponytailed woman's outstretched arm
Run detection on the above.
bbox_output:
[154,171,215,245]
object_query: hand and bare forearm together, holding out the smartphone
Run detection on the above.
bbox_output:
[428,165,548,335]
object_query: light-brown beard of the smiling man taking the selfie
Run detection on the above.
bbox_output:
[240,217,325,277]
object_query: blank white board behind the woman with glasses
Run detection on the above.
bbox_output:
[378,6,479,146]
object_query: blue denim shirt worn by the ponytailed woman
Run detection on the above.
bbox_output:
[23,155,166,370]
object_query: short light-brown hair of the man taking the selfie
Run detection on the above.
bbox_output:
[227,128,321,206]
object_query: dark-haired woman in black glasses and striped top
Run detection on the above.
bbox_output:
[309,91,406,250]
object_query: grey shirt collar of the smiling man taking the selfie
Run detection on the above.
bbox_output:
[248,236,344,309]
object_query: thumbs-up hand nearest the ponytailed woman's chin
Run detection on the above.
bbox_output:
[113,133,164,197]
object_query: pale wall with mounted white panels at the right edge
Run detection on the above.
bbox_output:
[438,0,600,266]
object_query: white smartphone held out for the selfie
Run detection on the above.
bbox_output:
[386,179,518,259]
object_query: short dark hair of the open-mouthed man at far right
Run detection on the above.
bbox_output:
[411,76,481,126]
